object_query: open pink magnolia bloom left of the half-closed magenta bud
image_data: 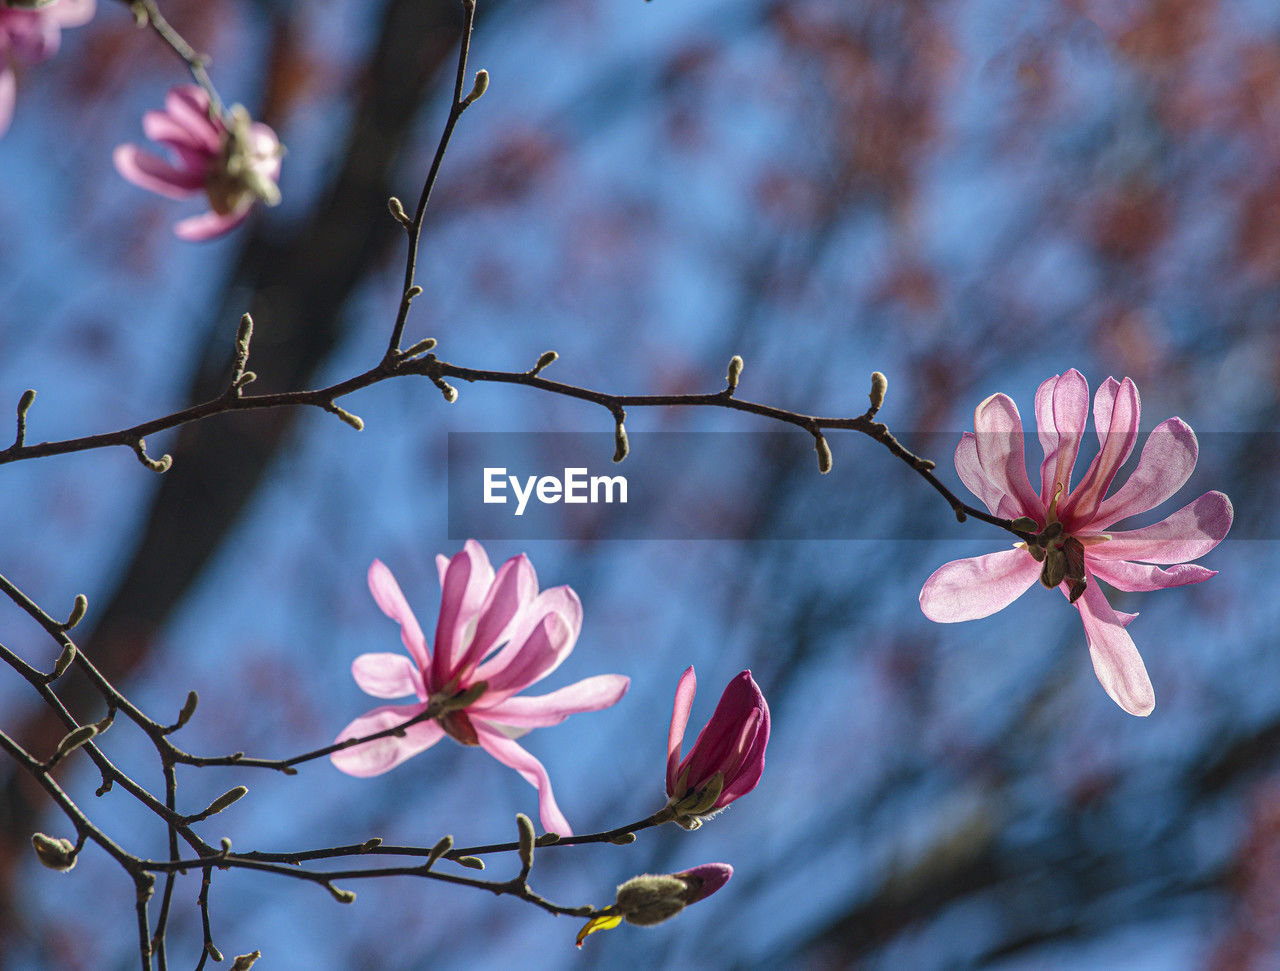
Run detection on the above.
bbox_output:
[330,540,630,835]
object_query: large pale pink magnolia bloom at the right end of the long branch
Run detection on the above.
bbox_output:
[920,370,1233,715]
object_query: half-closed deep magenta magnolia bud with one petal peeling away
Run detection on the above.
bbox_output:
[667,668,769,829]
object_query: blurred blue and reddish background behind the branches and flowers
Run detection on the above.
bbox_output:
[0,0,1280,971]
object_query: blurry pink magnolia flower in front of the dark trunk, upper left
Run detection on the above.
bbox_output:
[114,84,284,241]
